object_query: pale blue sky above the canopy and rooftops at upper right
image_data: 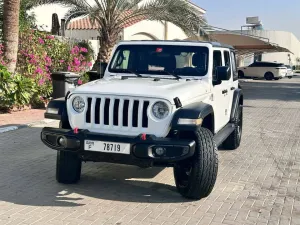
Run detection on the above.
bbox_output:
[192,0,300,40]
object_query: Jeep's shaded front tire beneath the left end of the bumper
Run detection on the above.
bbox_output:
[56,121,82,184]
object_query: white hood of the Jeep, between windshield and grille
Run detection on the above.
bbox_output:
[72,77,209,104]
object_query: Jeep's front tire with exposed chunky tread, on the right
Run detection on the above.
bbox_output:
[174,127,218,200]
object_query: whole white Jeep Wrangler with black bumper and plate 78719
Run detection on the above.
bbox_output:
[41,41,243,199]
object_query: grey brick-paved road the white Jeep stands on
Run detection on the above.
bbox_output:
[0,78,300,225]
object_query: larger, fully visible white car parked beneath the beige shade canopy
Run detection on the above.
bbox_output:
[238,62,287,80]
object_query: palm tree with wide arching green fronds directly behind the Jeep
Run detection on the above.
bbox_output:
[33,0,207,62]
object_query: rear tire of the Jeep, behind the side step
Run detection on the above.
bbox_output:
[223,105,243,150]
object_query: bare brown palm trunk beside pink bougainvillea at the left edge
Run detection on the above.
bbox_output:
[3,0,20,72]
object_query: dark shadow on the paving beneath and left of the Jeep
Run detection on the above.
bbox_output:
[0,128,188,207]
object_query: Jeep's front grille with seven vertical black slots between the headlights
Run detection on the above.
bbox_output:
[85,97,149,128]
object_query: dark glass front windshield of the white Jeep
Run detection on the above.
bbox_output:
[108,45,208,77]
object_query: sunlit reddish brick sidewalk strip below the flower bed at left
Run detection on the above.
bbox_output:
[0,109,45,126]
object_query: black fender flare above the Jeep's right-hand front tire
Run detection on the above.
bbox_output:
[171,102,214,131]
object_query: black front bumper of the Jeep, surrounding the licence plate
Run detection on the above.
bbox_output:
[41,127,196,166]
